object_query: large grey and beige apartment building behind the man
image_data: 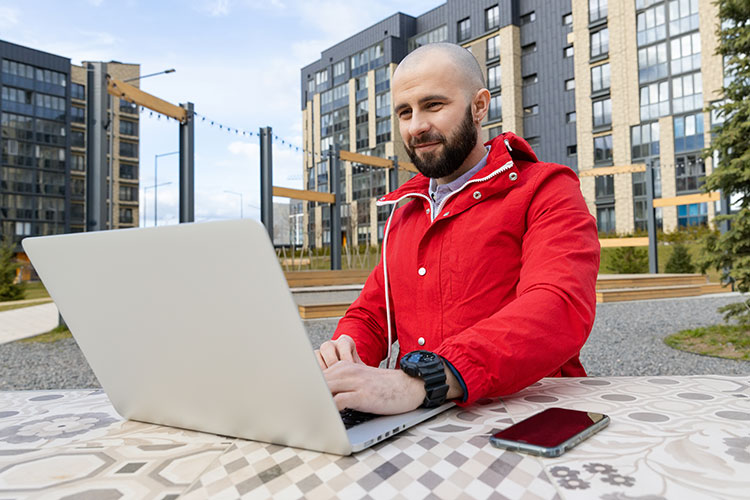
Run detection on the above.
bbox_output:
[300,0,722,246]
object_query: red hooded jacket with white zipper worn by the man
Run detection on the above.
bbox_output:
[334,133,600,404]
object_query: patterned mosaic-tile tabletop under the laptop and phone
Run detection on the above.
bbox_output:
[0,375,750,500]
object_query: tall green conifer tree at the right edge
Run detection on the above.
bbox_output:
[700,0,750,322]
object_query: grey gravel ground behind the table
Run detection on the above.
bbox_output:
[0,294,750,390]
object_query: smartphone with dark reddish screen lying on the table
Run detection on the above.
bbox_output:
[490,408,609,457]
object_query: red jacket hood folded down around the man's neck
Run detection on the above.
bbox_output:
[378,132,539,203]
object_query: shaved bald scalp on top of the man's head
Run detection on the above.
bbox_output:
[393,43,486,96]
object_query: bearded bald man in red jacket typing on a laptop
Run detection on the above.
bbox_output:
[316,44,599,414]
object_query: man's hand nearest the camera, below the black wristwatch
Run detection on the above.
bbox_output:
[321,362,425,415]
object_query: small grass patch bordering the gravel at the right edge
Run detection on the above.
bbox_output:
[664,325,750,361]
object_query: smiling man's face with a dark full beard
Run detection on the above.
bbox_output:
[393,61,477,179]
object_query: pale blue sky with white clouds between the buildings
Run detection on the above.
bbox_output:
[0,0,443,226]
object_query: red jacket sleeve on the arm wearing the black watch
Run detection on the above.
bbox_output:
[436,164,600,405]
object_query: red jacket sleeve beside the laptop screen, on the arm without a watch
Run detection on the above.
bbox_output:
[333,252,396,366]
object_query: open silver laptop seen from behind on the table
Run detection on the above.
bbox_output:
[23,219,453,455]
